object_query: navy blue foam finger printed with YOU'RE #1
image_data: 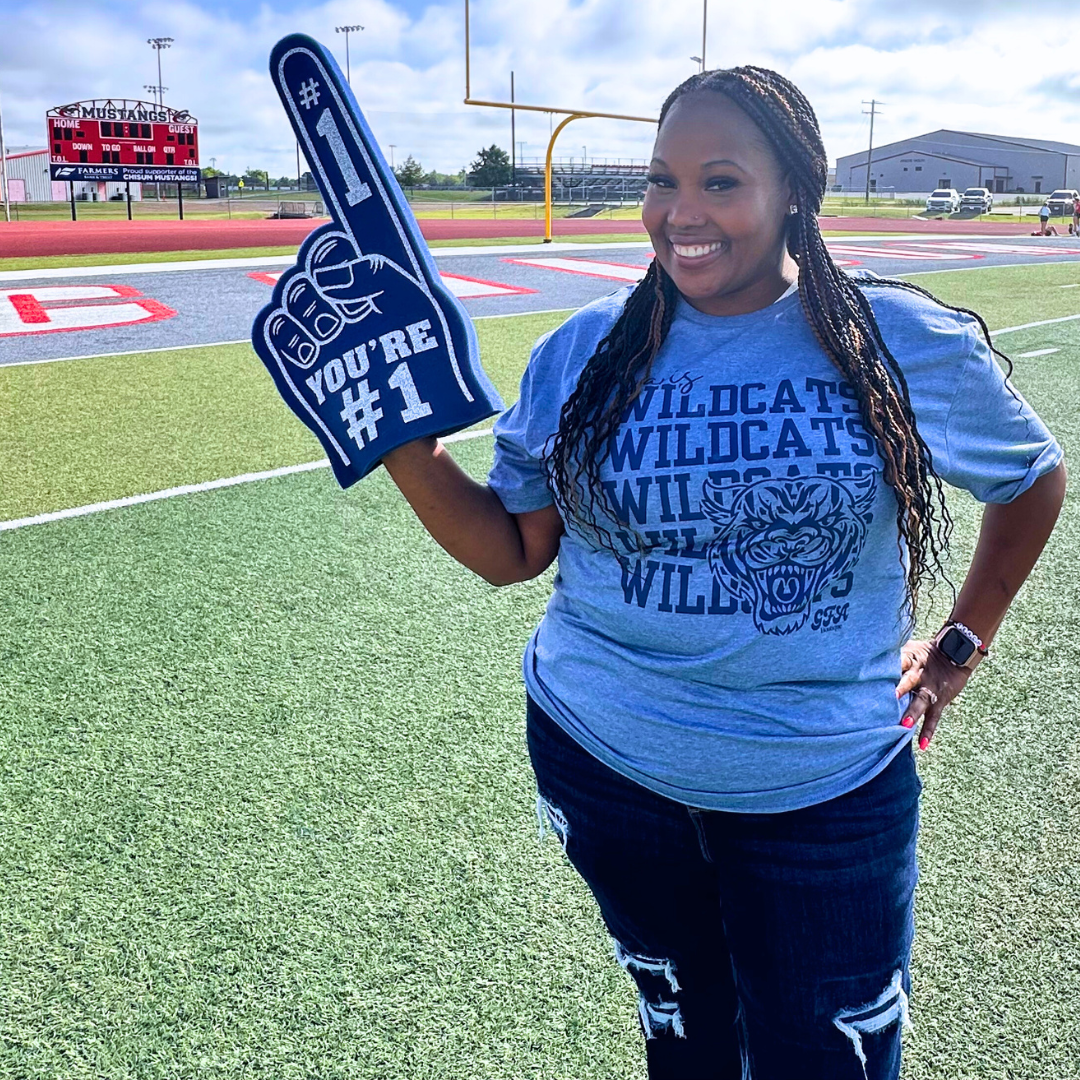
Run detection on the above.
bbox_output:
[252,33,502,487]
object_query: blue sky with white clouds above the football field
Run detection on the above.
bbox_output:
[0,0,1080,181]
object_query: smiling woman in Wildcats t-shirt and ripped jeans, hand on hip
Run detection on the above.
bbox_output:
[386,67,1065,1080]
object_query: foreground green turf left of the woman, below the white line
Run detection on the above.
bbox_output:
[0,440,642,1080]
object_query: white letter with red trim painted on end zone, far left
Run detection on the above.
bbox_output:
[0,285,176,337]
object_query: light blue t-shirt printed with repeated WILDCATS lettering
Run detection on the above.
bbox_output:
[489,278,1062,812]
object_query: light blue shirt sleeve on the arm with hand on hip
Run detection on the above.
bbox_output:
[934,327,1063,502]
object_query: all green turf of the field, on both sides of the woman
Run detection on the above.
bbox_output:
[0,265,1080,1080]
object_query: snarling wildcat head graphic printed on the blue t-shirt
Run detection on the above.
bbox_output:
[701,472,877,634]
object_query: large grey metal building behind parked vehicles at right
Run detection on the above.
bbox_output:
[836,129,1080,194]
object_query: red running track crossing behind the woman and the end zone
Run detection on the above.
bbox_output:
[0,217,1034,258]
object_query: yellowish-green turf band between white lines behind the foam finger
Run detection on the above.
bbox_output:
[0,312,566,521]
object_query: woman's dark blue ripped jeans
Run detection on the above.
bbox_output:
[527,700,921,1080]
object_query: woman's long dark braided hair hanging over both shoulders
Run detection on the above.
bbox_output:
[546,67,1012,613]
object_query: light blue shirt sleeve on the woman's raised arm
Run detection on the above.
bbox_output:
[487,334,562,514]
